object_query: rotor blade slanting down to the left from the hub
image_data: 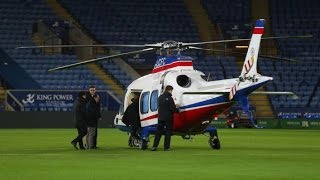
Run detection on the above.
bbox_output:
[48,48,154,72]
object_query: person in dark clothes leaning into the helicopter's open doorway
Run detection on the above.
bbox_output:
[122,97,141,147]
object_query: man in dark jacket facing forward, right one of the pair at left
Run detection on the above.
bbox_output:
[86,95,101,149]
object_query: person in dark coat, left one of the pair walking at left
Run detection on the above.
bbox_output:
[71,91,87,149]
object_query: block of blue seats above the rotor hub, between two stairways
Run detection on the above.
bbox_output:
[61,0,199,44]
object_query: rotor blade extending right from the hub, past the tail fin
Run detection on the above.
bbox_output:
[182,35,312,46]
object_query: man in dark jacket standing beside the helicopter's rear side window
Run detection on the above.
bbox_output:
[151,85,179,151]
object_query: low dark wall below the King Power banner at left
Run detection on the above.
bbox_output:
[0,111,117,128]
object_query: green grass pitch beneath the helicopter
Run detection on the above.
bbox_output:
[0,129,320,180]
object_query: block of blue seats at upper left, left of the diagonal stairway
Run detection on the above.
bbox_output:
[0,0,108,90]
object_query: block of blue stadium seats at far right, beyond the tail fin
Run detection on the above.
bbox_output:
[260,0,320,115]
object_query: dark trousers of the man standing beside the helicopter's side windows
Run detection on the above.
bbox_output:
[153,121,173,149]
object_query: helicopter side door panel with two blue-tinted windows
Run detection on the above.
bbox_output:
[140,88,160,127]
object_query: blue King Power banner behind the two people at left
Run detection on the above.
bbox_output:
[7,90,120,111]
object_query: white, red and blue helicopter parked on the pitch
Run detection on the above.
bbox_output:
[18,19,310,150]
